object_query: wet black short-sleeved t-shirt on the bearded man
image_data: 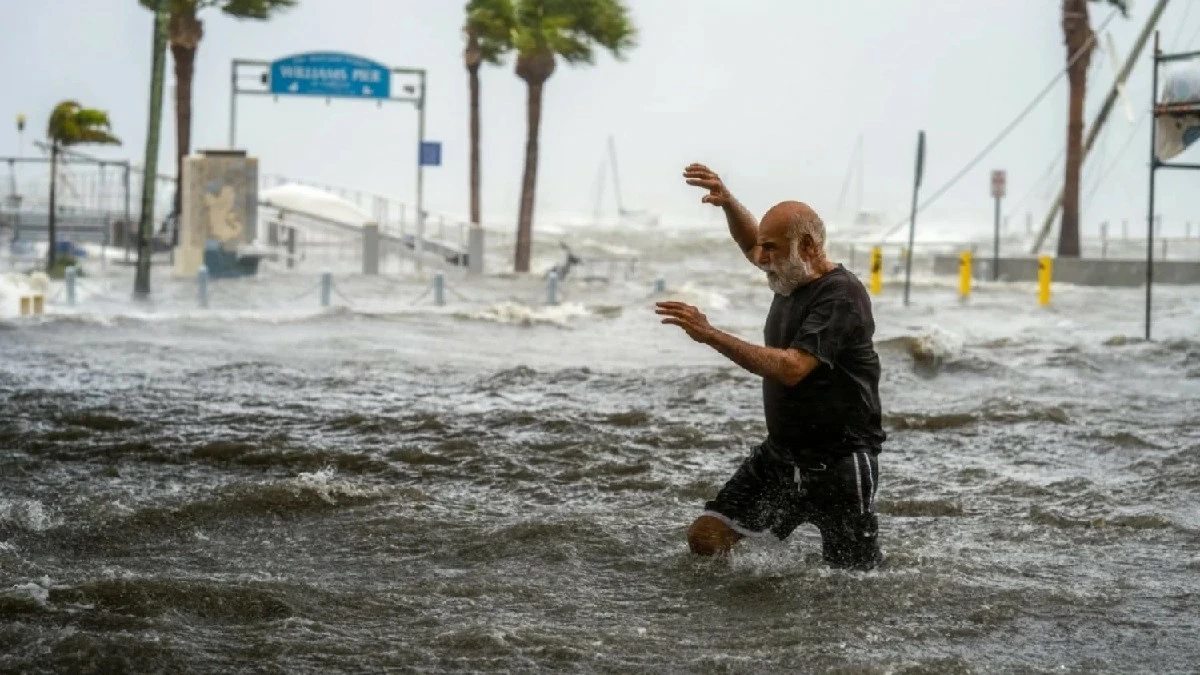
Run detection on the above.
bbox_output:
[762,265,887,456]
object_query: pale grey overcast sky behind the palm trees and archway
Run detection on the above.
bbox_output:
[0,0,1200,232]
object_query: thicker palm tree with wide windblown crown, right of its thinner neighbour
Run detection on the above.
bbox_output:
[512,0,636,271]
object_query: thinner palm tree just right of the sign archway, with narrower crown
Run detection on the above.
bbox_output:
[462,0,514,225]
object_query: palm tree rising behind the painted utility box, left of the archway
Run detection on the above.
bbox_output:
[138,0,298,214]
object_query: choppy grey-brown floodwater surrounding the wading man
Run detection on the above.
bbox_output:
[0,228,1200,674]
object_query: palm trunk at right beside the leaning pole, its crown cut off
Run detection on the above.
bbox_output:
[1058,0,1129,258]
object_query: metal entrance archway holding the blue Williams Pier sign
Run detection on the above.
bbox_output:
[229,52,440,267]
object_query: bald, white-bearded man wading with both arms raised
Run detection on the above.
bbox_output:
[655,165,886,569]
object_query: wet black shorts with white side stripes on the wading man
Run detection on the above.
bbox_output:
[704,443,883,569]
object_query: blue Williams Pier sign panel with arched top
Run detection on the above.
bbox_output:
[271,52,391,98]
